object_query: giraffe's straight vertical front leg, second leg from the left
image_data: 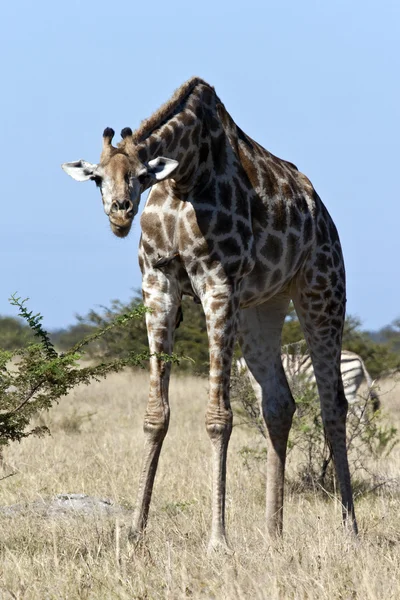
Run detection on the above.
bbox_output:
[203,289,239,551]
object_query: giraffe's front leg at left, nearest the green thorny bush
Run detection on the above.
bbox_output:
[131,288,180,540]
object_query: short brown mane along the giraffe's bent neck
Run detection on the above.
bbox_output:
[132,77,215,144]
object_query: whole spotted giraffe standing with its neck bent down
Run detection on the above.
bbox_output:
[62,77,357,549]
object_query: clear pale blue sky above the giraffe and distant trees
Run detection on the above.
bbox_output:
[0,0,400,329]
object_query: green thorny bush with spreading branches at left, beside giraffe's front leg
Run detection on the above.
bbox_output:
[0,296,177,446]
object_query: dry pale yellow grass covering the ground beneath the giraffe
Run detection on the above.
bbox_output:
[0,372,400,600]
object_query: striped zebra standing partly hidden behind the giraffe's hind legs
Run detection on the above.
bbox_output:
[236,348,380,412]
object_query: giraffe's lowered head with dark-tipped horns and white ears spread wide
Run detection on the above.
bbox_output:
[61,127,178,237]
